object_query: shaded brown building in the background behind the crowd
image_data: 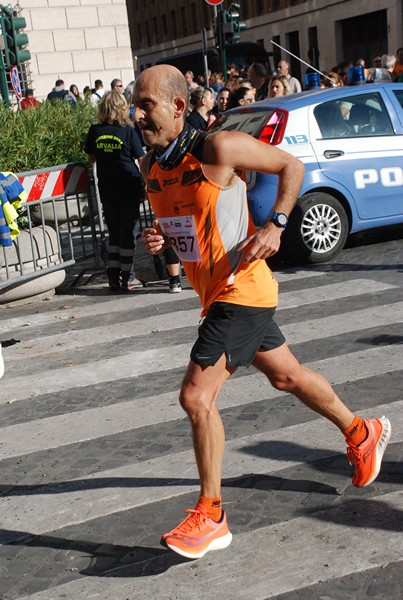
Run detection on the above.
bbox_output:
[127,0,403,78]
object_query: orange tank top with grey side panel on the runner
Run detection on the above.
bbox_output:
[147,152,278,316]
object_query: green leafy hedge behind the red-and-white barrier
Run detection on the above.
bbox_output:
[0,101,97,173]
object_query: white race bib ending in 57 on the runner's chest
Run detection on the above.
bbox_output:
[158,215,201,262]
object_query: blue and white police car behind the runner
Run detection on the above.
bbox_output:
[213,82,403,263]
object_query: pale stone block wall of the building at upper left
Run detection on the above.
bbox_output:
[20,0,134,99]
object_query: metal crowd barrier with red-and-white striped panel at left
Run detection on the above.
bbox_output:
[0,163,104,292]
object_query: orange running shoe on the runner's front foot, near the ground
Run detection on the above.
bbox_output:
[161,508,232,558]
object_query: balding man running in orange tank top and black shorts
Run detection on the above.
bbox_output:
[134,65,391,558]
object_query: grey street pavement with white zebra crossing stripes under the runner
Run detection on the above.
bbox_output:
[0,230,403,600]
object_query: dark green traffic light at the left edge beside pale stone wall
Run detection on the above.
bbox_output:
[0,4,31,68]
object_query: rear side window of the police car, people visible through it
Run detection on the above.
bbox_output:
[314,93,394,139]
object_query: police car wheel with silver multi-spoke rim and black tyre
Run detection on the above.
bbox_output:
[284,192,349,263]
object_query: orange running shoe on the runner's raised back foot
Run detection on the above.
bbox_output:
[346,417,392,487]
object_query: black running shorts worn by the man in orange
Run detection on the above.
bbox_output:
[190,302,285,367]
